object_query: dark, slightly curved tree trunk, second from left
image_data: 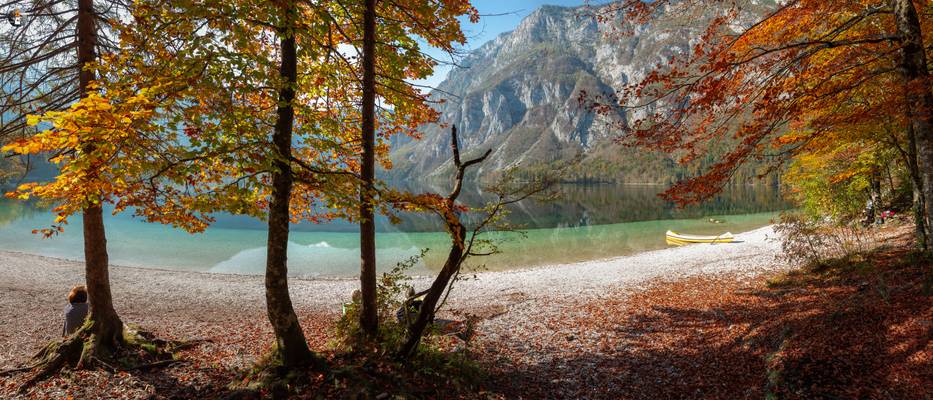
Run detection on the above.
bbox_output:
[266,7,313,367]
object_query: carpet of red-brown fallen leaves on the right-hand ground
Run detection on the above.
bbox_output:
[483,227,933,399]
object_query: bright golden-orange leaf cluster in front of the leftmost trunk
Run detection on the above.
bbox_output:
[4,81,203,236]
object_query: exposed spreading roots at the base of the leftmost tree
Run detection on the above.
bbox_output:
[12,323,203,393]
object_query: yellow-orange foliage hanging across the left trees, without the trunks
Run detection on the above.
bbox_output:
[2,0,478,236]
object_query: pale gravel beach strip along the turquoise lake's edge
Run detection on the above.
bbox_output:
[0,227,784,367]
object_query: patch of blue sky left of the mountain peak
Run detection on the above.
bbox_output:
[415,0,593,87]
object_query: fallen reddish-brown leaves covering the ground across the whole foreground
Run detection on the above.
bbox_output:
[0,227,933,399]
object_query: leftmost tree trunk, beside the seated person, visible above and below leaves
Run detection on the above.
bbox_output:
[77,0,123,350]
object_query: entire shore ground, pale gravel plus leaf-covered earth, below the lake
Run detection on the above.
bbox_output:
[0,226,933,399]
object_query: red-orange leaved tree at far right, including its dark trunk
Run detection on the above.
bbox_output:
[581,0,933,247]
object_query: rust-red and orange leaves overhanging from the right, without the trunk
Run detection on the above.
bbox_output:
[581,0,912,202]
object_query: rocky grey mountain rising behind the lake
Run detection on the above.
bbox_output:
[386,0,774,183]
